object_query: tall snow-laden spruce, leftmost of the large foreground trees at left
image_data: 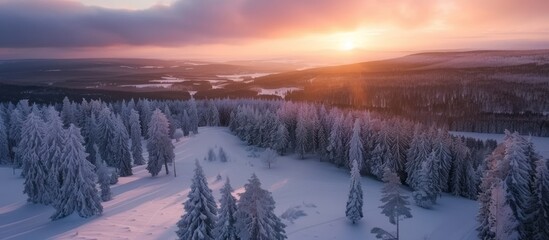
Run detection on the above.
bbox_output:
[16,112,52,204]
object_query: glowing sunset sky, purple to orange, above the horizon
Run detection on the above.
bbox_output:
[0,0,549,62]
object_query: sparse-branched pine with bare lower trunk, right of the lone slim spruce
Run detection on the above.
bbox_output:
[380,168,412,239]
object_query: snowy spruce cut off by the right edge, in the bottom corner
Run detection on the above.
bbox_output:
[528,159,549,240]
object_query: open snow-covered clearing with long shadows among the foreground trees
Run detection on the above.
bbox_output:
[0,127,478,240]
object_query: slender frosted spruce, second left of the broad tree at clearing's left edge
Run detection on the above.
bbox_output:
[109,116,133,177]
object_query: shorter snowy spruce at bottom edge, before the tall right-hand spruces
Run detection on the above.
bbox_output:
[489,181,521,240]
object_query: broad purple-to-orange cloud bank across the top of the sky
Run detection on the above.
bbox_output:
[0,0,549,48]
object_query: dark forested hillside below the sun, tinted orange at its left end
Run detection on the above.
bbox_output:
[286,65,549,136]
